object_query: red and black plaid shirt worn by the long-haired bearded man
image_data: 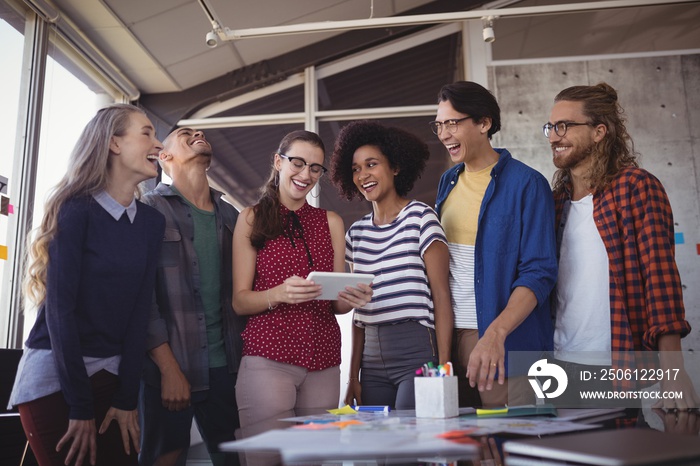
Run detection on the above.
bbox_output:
[554,167,690,388]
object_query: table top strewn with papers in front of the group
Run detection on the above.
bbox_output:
[221,408,700,466]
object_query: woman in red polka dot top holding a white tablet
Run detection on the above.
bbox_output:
[233,131,372,428]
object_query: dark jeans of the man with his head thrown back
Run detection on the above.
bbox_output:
[139,367,240,466]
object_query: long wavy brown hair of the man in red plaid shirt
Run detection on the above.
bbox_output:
[552,82,639,192]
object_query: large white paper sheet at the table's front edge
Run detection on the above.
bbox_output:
[220,429,479,462]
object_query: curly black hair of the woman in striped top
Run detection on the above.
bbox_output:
[331,121,430,201]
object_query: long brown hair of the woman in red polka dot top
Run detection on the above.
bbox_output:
[250,130,326,250]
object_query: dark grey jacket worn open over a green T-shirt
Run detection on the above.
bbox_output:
[142,183,247,392]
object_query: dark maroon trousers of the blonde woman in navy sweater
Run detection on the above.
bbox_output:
[18,370,138,466]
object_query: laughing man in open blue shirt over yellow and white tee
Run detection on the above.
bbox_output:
[430,81,557,406]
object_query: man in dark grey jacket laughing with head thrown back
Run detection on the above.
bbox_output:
[139,128,245,466]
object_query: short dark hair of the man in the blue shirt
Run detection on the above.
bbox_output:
[437,81,501,139]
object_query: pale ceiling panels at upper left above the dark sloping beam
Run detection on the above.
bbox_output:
[54,0,438,93]
